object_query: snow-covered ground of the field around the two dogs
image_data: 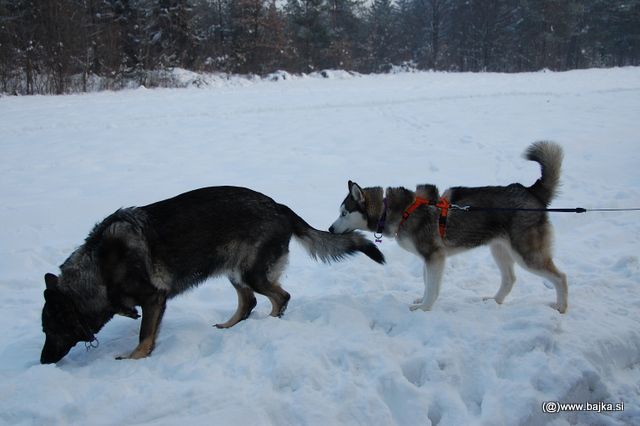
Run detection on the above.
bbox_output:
[0,68,640,425]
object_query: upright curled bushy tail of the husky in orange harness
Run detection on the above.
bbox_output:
[524,141,563,206]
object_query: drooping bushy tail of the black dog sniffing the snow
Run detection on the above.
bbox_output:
[281,205,384,263]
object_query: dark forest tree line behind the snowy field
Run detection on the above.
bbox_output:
[0,0,640,94]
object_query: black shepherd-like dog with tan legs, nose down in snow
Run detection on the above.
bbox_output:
[40,186,384,364]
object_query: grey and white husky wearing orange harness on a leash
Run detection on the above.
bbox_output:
[329,141,568,313]
